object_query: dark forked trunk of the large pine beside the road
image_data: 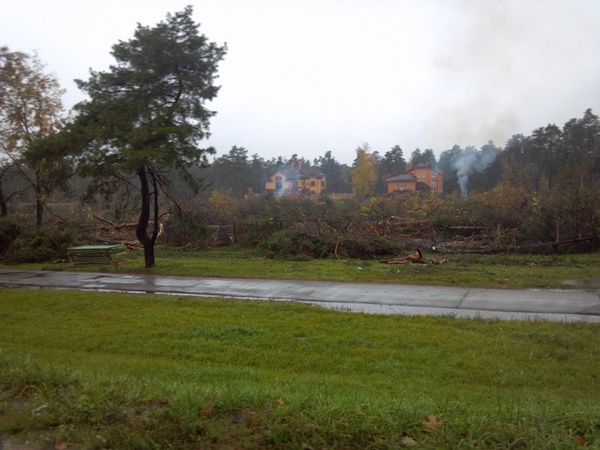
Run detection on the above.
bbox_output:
[136,167,158,269]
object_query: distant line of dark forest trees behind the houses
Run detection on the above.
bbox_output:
[197,109,600,198]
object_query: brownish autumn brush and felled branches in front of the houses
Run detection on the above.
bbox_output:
[156,183,600,259]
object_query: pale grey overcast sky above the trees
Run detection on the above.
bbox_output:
[0,0,600,164]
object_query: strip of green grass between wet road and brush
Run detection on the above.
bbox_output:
[0,246,600,289]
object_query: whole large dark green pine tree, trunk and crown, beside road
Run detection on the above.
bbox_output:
[71,7,226,267]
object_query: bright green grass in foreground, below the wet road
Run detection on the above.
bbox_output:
[0,288,600,450]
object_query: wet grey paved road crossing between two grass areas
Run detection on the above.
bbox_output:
[0,269,600,322]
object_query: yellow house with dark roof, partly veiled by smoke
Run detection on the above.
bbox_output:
[265,162,326,195]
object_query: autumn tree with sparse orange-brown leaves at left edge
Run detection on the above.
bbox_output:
[0,47,71,227]
